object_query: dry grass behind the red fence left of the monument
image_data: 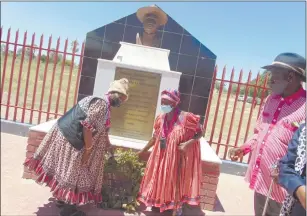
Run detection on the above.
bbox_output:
[1,56,78,124]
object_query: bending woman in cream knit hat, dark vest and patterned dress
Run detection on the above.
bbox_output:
[24,79,129,216]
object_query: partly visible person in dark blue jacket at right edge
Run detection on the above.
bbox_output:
[278,122,306,216]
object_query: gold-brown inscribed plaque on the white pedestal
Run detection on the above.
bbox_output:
[110,68,161,140]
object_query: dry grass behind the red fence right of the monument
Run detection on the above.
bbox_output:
[205,90,260,162]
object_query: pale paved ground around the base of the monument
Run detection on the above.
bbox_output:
[1,133,253,216]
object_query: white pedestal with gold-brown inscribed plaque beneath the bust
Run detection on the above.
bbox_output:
[93,42,181,141]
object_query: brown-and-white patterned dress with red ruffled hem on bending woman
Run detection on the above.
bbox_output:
[24,97,110,205]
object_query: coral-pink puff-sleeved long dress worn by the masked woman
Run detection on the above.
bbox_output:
[138,112,201,212]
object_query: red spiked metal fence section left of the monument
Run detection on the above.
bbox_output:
[0,27,84,125]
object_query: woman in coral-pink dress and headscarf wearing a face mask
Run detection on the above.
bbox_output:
[138,90,202,215]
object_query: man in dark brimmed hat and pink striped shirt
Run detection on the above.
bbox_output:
[229,53,306,216]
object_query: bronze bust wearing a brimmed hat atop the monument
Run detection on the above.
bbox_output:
[136,5,167,47]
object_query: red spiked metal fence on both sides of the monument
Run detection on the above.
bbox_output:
[0,28,268,162]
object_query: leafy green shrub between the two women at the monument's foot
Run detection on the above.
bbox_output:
[101,149,146,213]
